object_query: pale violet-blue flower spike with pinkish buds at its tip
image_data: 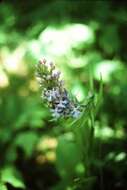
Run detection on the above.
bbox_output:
[37,59,82,118]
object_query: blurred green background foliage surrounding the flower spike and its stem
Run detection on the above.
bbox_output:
[0,0,127,190]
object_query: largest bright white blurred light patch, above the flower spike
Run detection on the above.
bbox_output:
[39,24,94,55]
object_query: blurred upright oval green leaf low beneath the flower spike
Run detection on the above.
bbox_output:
[56,134,81,178]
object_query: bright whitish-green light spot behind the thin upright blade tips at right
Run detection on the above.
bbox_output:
[94,60,120,82]
